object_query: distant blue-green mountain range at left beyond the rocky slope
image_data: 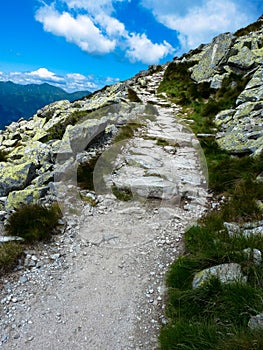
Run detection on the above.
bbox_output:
[0,81,90,129]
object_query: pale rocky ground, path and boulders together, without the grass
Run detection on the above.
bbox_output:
[0,15,263,349]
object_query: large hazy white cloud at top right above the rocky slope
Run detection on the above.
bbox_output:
[141,0,252,50]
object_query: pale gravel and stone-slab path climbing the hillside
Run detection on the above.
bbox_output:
[0,68,210,350]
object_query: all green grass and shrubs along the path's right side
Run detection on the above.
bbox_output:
[159,58,263,350]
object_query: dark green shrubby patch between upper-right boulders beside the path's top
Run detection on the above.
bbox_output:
[158,61,252,133]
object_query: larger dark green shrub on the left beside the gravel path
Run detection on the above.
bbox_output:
[6,204,61,242]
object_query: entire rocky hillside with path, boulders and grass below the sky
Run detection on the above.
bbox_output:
[0,18,263,350]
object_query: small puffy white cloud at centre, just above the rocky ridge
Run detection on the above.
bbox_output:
[126,33,173,64]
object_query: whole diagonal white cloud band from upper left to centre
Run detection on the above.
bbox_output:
[35,0,175,64]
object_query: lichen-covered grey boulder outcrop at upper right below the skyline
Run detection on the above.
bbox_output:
[175,18,263,155]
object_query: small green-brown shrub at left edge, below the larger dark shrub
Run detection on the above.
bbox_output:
[0,242,23,273]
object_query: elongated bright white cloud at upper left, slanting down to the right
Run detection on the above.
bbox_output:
[35,5,115,54]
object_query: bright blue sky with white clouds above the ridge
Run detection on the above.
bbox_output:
[0,0,263,91]
